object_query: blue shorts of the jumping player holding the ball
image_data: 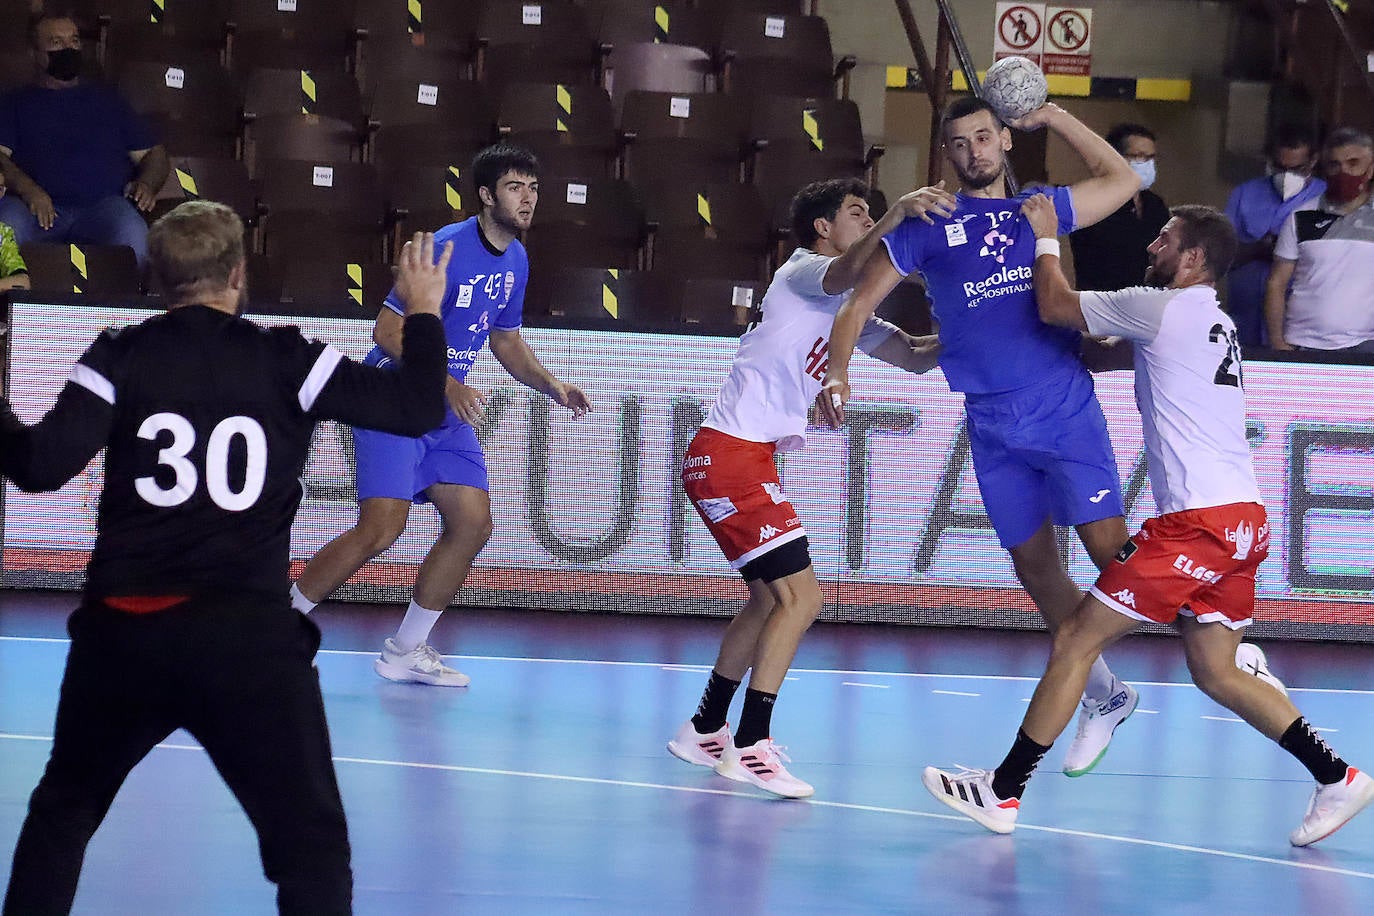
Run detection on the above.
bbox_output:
[965,371,1124,549]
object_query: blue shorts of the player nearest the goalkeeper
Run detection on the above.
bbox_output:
[353,413,486,503]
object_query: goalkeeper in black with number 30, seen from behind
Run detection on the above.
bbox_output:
[0,201,449,916]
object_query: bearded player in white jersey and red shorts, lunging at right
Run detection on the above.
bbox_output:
[922,195,1374,846]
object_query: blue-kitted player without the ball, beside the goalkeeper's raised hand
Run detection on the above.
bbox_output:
[291,144,591,687]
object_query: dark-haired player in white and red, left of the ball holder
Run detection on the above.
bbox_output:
[668,179,954,798]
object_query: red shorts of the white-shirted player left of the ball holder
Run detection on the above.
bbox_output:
[683,426,807,570]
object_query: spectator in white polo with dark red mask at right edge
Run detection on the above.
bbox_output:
[1264,128,1374,353]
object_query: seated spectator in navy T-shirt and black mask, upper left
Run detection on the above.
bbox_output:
[0,14,169,265]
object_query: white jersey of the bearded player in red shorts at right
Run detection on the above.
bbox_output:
[1080,284,1263,515]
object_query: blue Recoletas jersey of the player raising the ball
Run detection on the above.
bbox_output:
[882,187,1084,394]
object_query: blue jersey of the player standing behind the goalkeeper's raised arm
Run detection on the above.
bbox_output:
[364,217,529,382]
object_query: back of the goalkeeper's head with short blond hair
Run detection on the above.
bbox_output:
[148,201,243,302]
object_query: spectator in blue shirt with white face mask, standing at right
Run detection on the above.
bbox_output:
[1226,125,1326,346]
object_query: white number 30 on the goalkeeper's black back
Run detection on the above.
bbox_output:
[133,413,267,512]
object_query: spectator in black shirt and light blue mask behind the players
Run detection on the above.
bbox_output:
[1069,124,1169,291]
